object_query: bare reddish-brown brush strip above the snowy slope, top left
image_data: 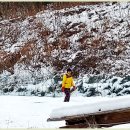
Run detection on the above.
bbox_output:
[0,2,101,19]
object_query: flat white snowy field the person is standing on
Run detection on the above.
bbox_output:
[0,95,130,128]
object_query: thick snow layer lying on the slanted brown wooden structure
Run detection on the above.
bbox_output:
[51,96,130,118]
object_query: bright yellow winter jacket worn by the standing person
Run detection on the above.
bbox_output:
[62,74,75,88]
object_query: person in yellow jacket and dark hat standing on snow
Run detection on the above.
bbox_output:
[62,68,76,102]
